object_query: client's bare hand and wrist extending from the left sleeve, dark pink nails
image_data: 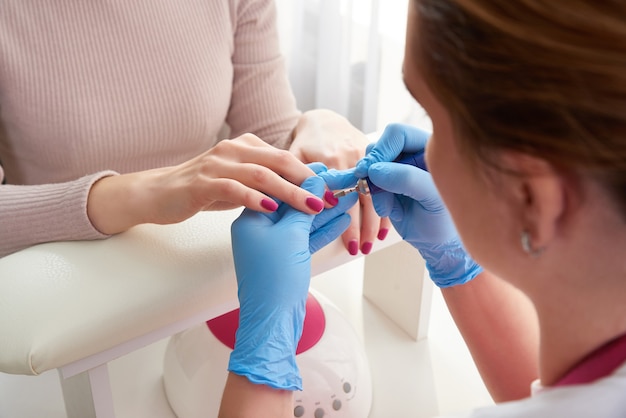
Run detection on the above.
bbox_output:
[87,134,324,234]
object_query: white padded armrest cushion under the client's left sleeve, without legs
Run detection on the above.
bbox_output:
[0,209,241,374]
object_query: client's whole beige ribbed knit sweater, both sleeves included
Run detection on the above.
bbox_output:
[0,0,299,256]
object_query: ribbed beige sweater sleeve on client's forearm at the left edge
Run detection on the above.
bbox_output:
[0,171,117,257]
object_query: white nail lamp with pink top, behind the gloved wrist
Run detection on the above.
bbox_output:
[163,291,372,418]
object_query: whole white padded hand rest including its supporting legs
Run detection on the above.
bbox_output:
[0,210,432,418]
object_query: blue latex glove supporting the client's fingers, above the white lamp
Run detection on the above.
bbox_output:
[228,176,357,390]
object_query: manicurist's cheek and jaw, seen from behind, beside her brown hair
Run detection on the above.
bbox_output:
[403,1,519,275]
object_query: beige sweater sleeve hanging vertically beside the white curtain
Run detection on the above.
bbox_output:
[227,0,300,149]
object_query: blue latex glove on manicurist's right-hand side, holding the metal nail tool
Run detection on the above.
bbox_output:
[321,124,482,288]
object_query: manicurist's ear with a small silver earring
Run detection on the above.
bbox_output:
[503,152,570,250]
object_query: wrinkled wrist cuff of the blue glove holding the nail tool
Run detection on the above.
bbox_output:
[418,241,483,288]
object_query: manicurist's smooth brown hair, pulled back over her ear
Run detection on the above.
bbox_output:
[412,0,626,217]
